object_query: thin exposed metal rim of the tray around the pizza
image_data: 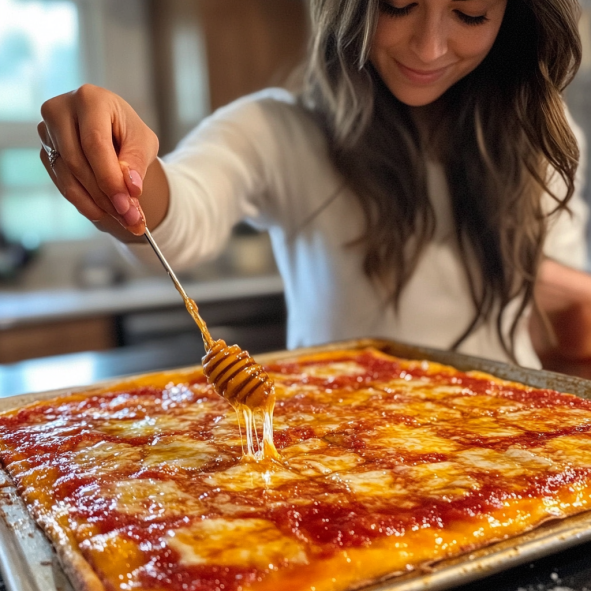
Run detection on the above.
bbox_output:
[0,338,591,591]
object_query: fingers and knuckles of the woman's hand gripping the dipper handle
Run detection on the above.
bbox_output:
[38,85,158,234]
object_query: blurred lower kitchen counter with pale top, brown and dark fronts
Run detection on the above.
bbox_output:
[0,272,286,371]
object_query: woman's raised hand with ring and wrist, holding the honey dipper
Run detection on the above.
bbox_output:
[37,84,168,241]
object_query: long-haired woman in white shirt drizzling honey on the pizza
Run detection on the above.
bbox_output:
[39,0,591,371]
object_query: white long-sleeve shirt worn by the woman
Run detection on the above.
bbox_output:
[125,89,586,367]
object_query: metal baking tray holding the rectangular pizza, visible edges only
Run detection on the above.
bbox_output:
[0,339,591,591]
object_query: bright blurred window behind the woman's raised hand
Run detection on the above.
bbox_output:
[0,0,96,246]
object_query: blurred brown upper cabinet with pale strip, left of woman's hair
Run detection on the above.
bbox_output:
[149,0,309,154]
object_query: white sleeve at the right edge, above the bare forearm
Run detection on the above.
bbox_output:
[544,111,589,270]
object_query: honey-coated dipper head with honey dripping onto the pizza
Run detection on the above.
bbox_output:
[185,298,279,460]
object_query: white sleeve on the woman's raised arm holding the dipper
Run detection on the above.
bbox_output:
[123,89,296,270]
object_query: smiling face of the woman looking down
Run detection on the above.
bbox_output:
[370,0,507,107]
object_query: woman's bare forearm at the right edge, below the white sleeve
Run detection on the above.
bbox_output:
[530,259,591,378]
